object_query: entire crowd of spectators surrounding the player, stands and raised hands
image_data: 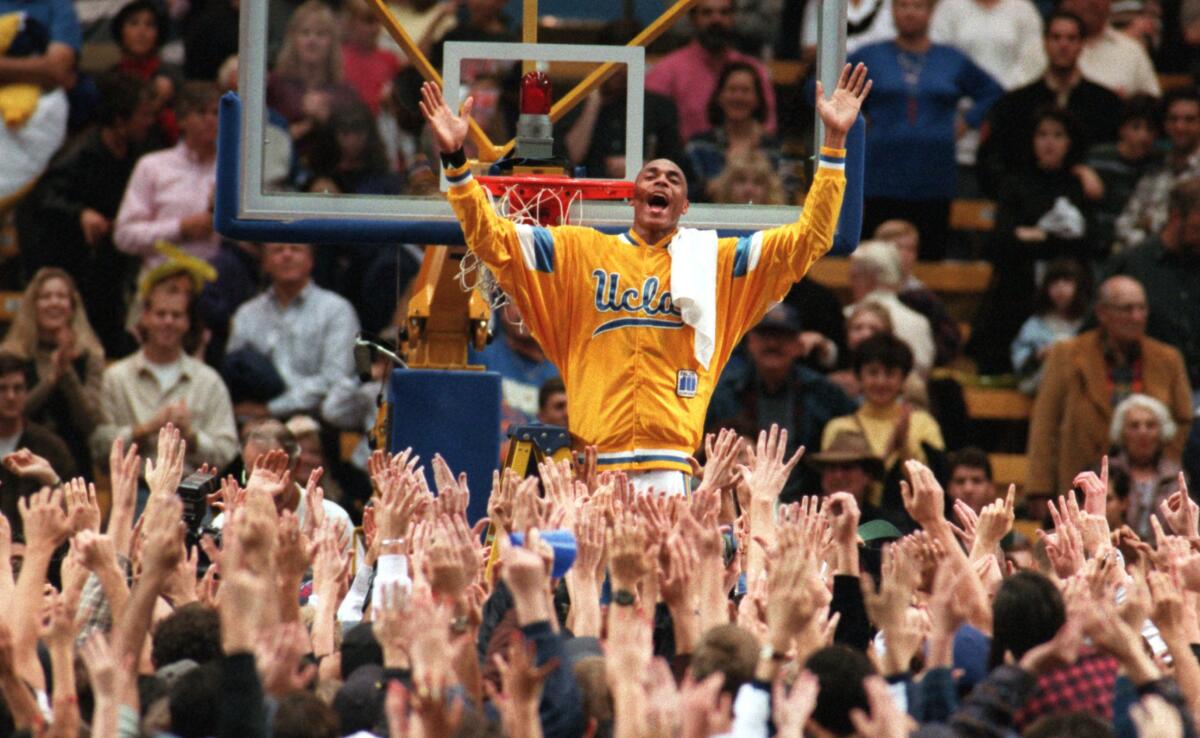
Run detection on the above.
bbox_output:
[0,0,1200,738]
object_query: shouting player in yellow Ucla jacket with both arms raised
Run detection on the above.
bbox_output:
[421,65,871,493]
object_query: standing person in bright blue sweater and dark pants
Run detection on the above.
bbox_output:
[850,0,1003,259]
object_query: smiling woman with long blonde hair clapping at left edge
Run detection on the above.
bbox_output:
[0,266,104,469]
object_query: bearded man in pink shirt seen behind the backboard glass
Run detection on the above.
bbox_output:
[646,0,775,140]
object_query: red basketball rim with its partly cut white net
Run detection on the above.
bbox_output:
[458,174,634,311]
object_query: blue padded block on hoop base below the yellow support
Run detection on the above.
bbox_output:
[388,370,500,523]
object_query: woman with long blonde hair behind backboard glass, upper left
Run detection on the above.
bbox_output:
[266,0,358,149]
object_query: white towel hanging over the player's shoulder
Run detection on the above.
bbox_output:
[667,228,716,370]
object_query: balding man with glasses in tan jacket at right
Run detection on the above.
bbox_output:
[1026,276,1192,494]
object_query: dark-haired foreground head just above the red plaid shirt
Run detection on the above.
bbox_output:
[988,571,1067,670]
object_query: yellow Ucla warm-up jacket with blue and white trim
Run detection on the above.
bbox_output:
[445,149,846,473]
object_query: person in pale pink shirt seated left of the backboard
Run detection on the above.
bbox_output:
[113,82,221,266]
